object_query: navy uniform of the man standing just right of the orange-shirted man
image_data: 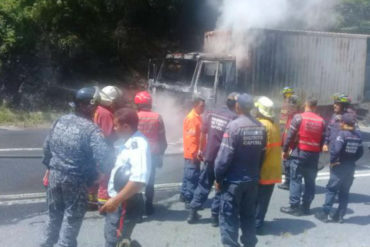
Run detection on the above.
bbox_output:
[190,106,237,216]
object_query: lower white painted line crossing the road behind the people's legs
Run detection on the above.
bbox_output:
[0,171,370,206]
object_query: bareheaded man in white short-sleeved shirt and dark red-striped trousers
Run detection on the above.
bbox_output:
[100,108,151,247]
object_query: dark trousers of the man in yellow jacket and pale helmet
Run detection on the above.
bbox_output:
[256,184,275,228]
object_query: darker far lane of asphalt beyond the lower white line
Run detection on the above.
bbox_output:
[0,128,370,195]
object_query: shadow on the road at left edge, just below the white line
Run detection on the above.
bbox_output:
[0,203,47,225]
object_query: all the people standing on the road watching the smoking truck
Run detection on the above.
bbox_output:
[41,86,363,247]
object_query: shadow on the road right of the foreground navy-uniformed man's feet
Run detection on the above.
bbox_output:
[263,218,316,236]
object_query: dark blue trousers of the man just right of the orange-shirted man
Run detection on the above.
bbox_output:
[190,162,220,216]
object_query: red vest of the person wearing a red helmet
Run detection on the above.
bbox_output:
[137,111,160,154]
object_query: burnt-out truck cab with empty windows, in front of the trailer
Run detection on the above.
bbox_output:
[149,52,237,106]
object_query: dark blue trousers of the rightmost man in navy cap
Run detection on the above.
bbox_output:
[323,165,355,217]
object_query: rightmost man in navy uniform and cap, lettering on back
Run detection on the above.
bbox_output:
[315,113,364,223]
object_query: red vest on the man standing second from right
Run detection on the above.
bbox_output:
[298,112,325,152]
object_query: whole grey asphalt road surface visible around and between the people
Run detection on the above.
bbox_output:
[0,126,370,247]
